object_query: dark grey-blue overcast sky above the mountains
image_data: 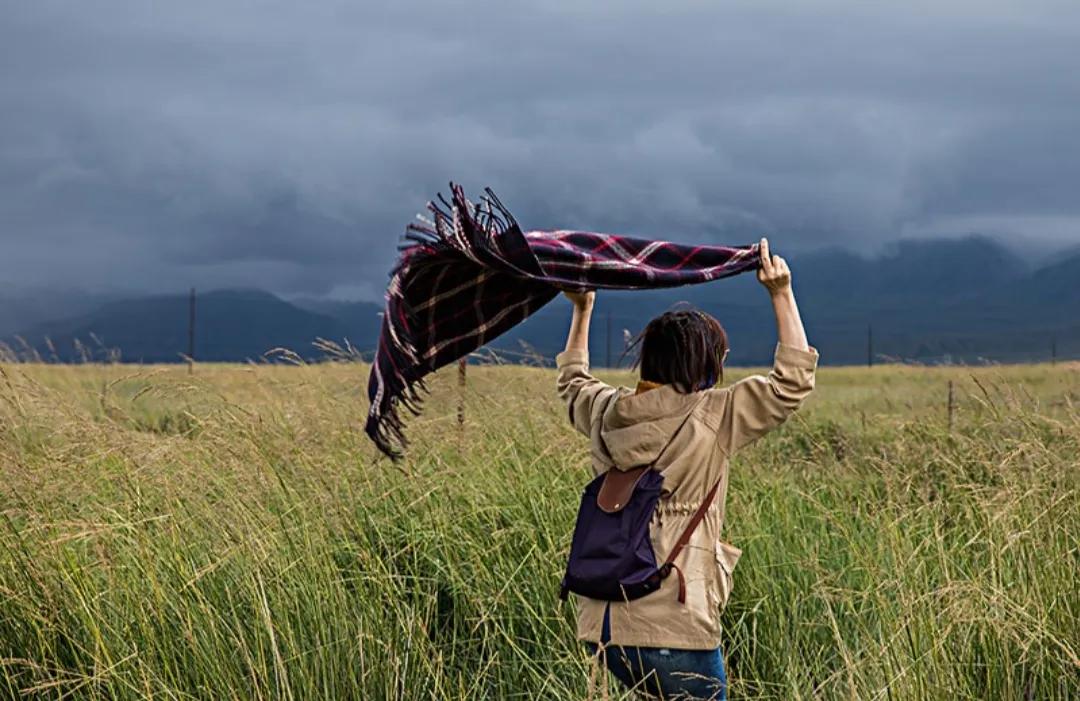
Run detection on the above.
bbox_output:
[0,0,1080,298]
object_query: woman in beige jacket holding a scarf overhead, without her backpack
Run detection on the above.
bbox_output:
[555,239,818,699]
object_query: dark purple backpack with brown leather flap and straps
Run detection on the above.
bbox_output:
[559,399,720,604]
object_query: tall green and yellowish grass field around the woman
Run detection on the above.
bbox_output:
[0,364,1080,701]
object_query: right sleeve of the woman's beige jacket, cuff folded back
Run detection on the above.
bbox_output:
[706,343,819,456]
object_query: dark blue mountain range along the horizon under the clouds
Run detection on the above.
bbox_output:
[0,237,1080,366]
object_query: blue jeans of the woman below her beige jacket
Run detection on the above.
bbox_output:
[585,608,728,701]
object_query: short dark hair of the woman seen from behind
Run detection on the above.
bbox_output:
[626,308,728,394]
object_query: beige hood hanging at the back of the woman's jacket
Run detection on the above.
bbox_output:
[600,385,701,469]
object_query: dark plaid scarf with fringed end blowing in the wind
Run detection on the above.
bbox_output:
[365,183,758,459]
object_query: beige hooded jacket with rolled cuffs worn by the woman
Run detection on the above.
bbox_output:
[555,343,818,649]
